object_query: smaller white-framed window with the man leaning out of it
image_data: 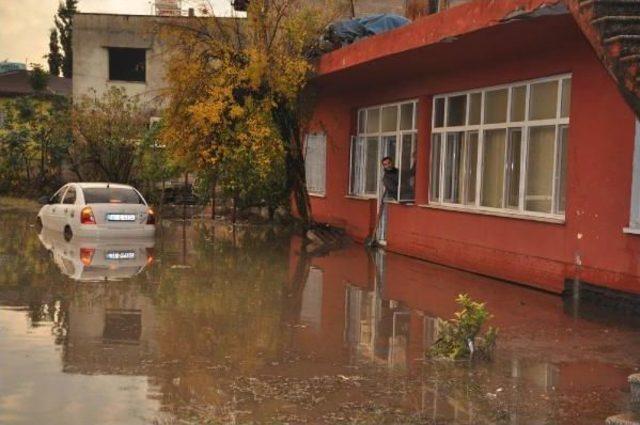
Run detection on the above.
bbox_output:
[349,101,417,202]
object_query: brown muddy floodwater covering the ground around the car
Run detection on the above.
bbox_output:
[0,211,640,425]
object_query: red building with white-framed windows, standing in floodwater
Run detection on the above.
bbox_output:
[307,0,640,294]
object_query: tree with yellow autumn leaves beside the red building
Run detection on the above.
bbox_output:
[162,0,342,227]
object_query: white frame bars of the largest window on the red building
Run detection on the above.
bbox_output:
[429,74,572,221]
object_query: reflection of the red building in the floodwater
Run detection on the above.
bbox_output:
[293,238,640,424]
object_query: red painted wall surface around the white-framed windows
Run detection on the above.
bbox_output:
[311,15,640,293]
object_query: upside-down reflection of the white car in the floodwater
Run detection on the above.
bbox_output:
[40,228,155,282]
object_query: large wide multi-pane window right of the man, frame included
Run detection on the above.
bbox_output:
[429,76,571,218]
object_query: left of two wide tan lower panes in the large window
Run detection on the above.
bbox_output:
[480,130,506,208]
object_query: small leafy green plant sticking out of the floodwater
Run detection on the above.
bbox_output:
[428,294,498,360]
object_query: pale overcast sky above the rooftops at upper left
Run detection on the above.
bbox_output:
[0,0,238,64]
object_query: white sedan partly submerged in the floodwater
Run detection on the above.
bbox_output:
[37,183,156,240]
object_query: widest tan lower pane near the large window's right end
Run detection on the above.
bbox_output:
[525,126,556,213]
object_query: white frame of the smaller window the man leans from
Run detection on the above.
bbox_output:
[348,99,418,202]
